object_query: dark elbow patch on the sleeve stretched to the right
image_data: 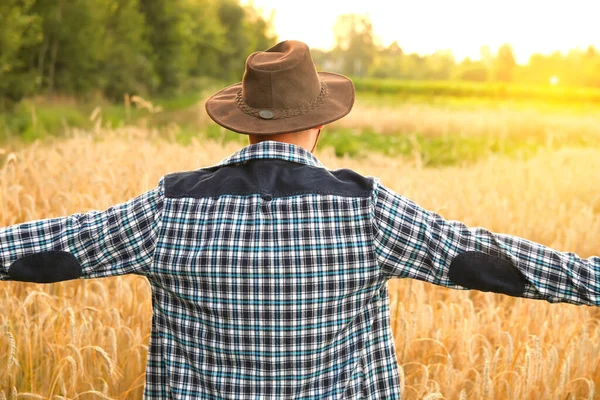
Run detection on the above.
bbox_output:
[448,251,527,296]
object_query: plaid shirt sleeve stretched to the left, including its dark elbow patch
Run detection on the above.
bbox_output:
[0,178,164,283]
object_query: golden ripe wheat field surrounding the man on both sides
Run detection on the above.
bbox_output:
[0,128,600,400]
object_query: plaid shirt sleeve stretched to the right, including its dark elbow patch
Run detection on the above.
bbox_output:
[373,181,600,305]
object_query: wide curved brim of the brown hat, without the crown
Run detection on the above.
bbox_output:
[205,72,355,135]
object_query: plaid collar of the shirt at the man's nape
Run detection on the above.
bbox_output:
[218,140,325,168]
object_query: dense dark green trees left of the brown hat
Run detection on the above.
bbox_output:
[0,0,275,108]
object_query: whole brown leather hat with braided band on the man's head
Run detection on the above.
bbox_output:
[205,40,354,135]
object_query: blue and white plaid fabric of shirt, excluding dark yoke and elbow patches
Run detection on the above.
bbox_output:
[0,142,600,399]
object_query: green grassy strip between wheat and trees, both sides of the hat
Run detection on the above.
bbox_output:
[0,79,600,167]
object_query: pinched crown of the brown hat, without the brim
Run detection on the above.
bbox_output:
[242,40,321,109]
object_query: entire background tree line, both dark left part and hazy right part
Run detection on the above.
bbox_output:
[0,5,600,110]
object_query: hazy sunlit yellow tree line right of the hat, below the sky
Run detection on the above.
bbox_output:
[313,14,600,87]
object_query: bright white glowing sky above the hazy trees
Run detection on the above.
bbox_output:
[242,0,600,63]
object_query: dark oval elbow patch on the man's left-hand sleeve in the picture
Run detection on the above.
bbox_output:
[8,251,81,283]
